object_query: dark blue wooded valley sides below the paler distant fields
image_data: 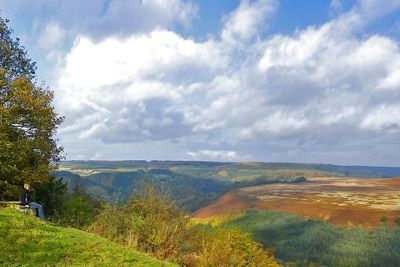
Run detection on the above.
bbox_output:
[55,169,231,211]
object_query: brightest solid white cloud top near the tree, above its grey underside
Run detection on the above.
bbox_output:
[60,30,225,93]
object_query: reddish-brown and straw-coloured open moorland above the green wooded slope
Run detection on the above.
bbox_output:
[193,177,400,228]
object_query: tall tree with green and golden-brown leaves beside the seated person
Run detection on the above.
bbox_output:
[0,17,62,199]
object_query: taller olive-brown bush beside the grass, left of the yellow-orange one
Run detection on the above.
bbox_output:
[90,186,197,261]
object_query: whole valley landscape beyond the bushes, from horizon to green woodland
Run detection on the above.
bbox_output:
[54,161,400,267]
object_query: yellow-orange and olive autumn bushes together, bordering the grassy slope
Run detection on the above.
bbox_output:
[90,186,278,266]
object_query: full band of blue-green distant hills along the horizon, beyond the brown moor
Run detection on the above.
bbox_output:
[55,161,400,211]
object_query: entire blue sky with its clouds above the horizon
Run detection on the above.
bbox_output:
[0,0,400,166]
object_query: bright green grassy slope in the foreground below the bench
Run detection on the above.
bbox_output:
[0,208,174,266]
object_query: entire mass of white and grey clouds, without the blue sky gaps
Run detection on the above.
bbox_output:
[15,0,400,161]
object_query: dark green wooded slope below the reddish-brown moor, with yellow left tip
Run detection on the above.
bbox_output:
[219,211,400,267]
